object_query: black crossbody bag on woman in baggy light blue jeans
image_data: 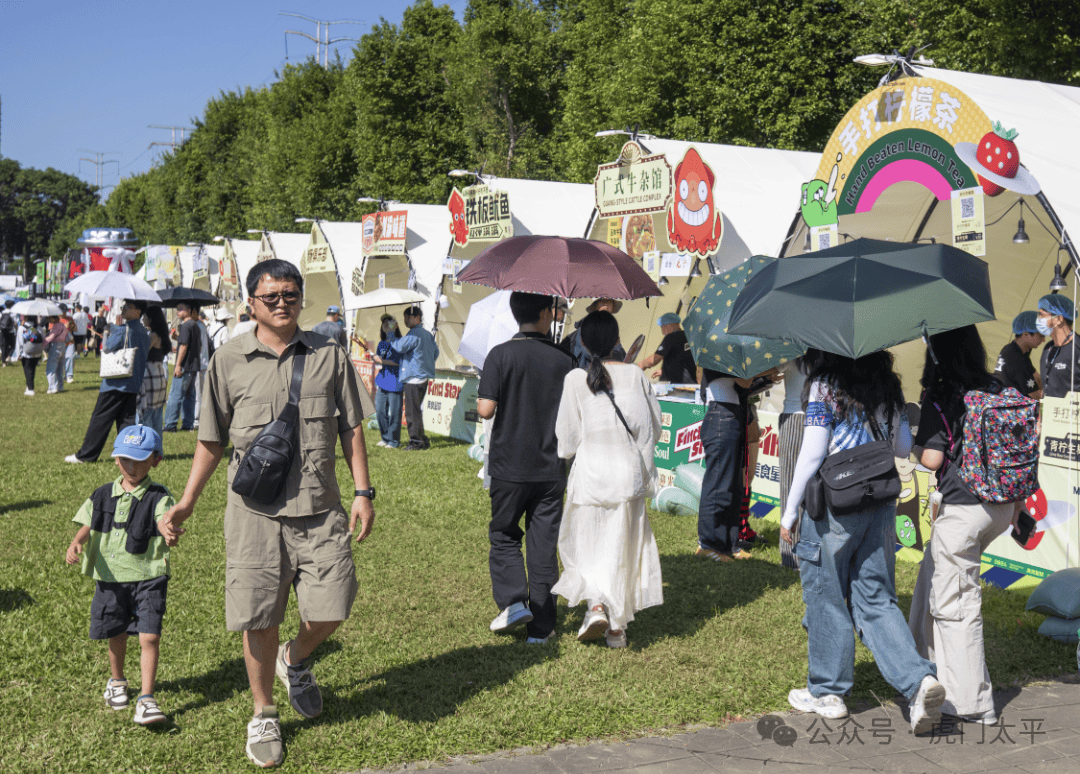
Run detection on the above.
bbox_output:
[802,408,901,521]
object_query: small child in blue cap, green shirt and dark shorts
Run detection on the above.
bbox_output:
[67,424,174,725]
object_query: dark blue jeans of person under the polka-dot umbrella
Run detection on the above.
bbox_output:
[698,402,746,554]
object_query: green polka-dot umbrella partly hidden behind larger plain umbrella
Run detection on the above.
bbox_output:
[683,256,804,379]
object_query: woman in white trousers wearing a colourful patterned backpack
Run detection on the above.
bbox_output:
[909,325,1018,724]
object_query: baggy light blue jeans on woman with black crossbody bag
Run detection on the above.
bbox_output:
[795,502,937,700]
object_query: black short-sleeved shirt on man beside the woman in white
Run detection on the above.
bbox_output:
[477,334,573,481]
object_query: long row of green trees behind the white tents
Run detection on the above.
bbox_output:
[31,0,1080,249]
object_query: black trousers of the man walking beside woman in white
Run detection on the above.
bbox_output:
[488,478,566,638]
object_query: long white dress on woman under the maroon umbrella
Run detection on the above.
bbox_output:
[552,363,664,629]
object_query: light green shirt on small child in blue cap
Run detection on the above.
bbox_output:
[71,476,176,583]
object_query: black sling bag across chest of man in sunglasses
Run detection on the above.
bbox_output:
[232,341,308,505]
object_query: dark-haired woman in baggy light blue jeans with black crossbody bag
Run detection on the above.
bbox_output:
[780,352,945,733]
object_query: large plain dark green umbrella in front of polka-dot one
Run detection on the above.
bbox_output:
[728,239,995,357]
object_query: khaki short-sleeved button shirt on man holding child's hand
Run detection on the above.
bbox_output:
[199,330,375,517]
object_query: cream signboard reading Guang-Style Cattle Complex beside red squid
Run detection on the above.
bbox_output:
[593,141,672,218]
